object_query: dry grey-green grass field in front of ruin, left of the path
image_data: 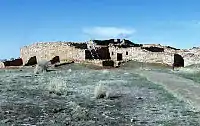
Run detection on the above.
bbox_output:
[0,64,200,126]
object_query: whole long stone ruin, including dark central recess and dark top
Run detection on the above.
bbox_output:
[21,39,200,66]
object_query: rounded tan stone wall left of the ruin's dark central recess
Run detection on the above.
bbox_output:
[20,42,85,64]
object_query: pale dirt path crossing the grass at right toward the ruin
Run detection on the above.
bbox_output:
[140,71,200,111]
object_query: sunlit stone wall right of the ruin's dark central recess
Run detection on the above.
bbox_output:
[109,45,200,66]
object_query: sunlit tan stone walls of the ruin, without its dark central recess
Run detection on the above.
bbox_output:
[20,42,200,66]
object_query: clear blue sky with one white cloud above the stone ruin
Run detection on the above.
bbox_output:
[0,0,200,59]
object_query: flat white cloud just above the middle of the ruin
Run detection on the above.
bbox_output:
[83,27,136,39]
